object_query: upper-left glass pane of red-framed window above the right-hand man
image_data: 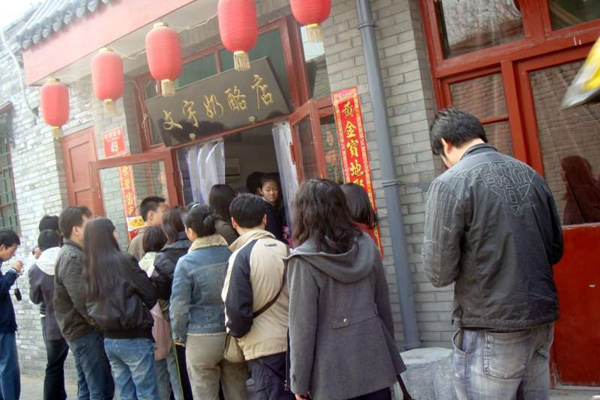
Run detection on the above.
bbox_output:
[435,0,523,58]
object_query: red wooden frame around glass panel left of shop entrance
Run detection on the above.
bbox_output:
[89,150,182,215]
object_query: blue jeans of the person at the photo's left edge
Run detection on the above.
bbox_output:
[0,332,21,400]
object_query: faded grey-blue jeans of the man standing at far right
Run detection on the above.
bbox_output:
[453,324,554,400]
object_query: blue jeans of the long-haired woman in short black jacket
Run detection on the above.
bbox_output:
[104,338,158,400]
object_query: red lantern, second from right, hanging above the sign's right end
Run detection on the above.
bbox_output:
[218,0,258,71]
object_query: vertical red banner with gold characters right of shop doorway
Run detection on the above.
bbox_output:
[331,87,383,256]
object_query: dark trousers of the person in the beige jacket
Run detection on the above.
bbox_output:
[248,353,296,400]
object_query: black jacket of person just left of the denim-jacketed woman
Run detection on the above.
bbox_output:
[150,232,192,301]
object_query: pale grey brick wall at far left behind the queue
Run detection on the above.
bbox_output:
[0,18,91,377]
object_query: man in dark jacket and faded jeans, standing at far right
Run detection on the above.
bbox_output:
[422,109,563,400]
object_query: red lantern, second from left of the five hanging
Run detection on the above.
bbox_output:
[92,48,125,115]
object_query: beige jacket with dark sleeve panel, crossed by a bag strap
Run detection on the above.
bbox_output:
[222,230,289,360]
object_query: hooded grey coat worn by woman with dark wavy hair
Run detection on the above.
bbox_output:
[288,233,406,400]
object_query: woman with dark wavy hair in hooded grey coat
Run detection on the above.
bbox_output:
[288,179,405,400]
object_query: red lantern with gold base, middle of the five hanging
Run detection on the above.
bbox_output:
[146,22,181,97]
